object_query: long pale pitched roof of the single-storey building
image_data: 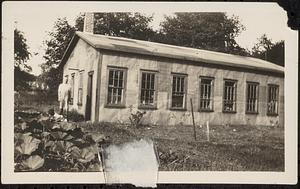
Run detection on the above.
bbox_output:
[60,32,284,74]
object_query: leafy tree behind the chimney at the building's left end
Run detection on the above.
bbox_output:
[40,13,155,92]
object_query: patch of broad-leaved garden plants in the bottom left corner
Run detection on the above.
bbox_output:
[14,108,105,171]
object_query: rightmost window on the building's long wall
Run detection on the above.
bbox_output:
[267,85,279,115]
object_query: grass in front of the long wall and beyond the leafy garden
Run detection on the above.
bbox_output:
[15,91,284,171]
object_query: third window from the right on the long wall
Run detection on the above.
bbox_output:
[223,80,237,113]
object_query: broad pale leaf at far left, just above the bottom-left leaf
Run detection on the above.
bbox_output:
[16,135,41,155]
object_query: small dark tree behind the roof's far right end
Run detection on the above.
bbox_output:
[251,34,284,66]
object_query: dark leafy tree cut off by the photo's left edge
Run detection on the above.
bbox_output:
[14,29,35,91]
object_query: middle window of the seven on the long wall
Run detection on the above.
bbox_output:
[200,77,213,111]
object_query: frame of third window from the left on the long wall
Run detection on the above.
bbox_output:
[170,72,188,111]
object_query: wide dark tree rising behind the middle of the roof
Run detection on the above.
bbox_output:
[155,13,248,55]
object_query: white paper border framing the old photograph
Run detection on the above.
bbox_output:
[1,1,298,184]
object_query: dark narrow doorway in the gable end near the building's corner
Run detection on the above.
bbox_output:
[85,72,93,121]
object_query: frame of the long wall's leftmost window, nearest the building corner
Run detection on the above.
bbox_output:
[104,66,128,108]
